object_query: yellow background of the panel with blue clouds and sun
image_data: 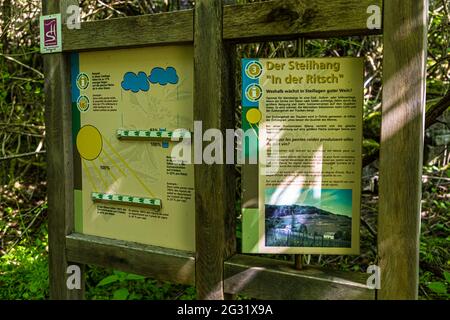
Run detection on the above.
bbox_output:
[75,46,195,251]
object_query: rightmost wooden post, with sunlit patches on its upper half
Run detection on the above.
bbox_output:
[378,0,428,299]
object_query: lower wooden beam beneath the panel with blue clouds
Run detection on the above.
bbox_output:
[66,233,195,285]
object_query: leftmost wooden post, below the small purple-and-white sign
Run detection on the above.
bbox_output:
[42,0,84,299]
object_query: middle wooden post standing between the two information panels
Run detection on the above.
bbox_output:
[194,0,236,299]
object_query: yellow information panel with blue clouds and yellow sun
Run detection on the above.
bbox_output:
[71,46,195,251]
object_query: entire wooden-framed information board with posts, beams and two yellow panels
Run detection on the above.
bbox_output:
[41,0,428,300]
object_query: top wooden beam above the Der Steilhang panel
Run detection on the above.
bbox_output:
[223,0,383,41]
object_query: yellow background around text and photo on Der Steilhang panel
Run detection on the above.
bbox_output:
[258,58,363,254]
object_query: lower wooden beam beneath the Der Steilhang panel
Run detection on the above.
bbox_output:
[225,255,375,300]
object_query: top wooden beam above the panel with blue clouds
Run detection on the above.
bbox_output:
[63,10,193,51]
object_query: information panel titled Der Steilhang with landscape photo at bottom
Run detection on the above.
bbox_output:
[242,58,363,254]
